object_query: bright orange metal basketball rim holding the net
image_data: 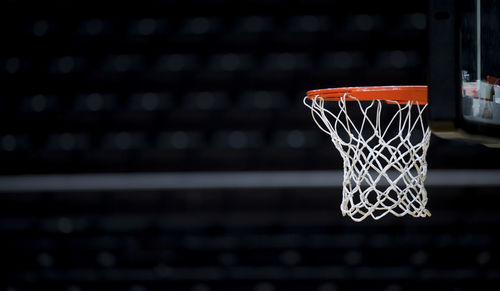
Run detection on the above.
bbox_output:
[307,86,427,105]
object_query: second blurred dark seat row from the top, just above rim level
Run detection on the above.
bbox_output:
[0,50,424,75]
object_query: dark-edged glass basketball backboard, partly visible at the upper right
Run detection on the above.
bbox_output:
[428,0,500,146]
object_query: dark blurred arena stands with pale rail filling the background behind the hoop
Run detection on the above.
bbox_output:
[0,0,500,291]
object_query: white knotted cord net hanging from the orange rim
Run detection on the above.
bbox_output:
[304,94,431,221]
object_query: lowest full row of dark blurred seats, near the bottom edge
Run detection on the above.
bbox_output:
[1,249,499,272]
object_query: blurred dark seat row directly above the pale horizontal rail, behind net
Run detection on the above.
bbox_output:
[0,133,496,174]
